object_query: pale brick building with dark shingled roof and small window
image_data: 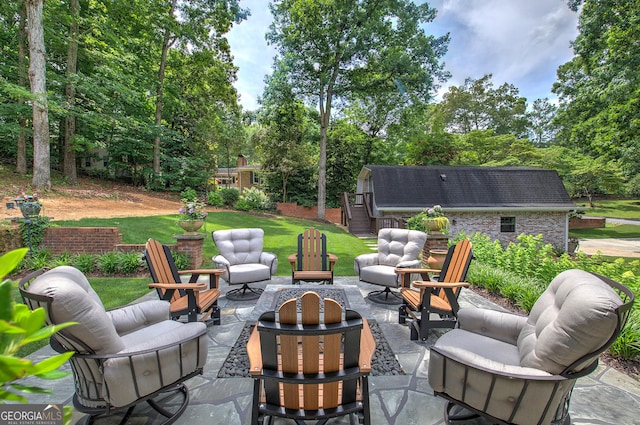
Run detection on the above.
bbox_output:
[357,165,578,250]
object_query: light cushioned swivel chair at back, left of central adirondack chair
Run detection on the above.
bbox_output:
[211,228,278,300]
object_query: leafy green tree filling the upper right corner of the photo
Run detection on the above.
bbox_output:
[553,0,640,178]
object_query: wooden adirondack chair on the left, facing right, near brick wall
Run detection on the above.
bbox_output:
[144,239,224,324]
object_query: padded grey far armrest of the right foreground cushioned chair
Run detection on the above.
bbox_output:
[458,308,527,345]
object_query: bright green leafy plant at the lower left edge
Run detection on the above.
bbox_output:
[0,248,75,423]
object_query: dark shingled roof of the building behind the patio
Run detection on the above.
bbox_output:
[365,165,575,209]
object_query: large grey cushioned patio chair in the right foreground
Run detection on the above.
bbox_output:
[428,269,634,425]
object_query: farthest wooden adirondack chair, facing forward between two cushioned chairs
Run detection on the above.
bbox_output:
[288,227,338,285]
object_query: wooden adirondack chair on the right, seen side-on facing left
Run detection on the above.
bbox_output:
[398,239,473,341]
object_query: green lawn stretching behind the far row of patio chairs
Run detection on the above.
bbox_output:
[53,211,371,276]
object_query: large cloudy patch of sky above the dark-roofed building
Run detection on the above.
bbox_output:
[427,0,578,101]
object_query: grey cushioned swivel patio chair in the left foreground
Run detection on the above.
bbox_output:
[20,266,208,424]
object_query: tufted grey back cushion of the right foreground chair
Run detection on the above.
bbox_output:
[517,269,622,374]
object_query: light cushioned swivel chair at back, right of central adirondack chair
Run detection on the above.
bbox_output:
[354,228,427,304]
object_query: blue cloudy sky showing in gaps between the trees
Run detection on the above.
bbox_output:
[227,0,578,110]
